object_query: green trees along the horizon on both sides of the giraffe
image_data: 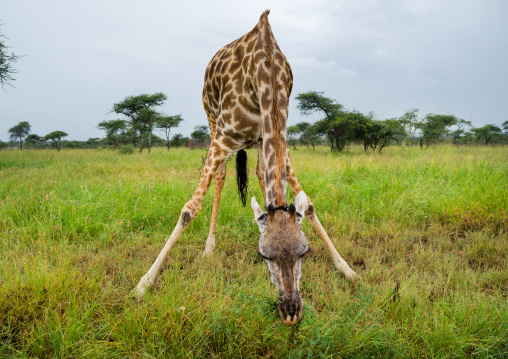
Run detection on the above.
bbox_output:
[0,91,508,153]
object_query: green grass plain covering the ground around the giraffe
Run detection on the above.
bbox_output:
[0,147,508,358]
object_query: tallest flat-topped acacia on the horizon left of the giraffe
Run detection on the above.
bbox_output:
[113,92,168,152]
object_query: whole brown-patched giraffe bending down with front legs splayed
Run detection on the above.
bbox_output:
[135,10,356,325]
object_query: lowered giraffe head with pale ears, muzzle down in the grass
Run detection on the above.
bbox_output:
[251,191,309,325]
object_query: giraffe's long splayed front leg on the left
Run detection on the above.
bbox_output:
[134,139,232,297]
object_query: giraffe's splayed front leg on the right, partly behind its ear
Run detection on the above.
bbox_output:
[286,150,357,281]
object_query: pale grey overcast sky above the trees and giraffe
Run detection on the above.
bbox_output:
[0,0,508,141]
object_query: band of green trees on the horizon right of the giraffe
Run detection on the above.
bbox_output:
[287,91,508,152]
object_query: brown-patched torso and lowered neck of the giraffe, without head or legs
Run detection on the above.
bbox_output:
[203,11,293,207]
